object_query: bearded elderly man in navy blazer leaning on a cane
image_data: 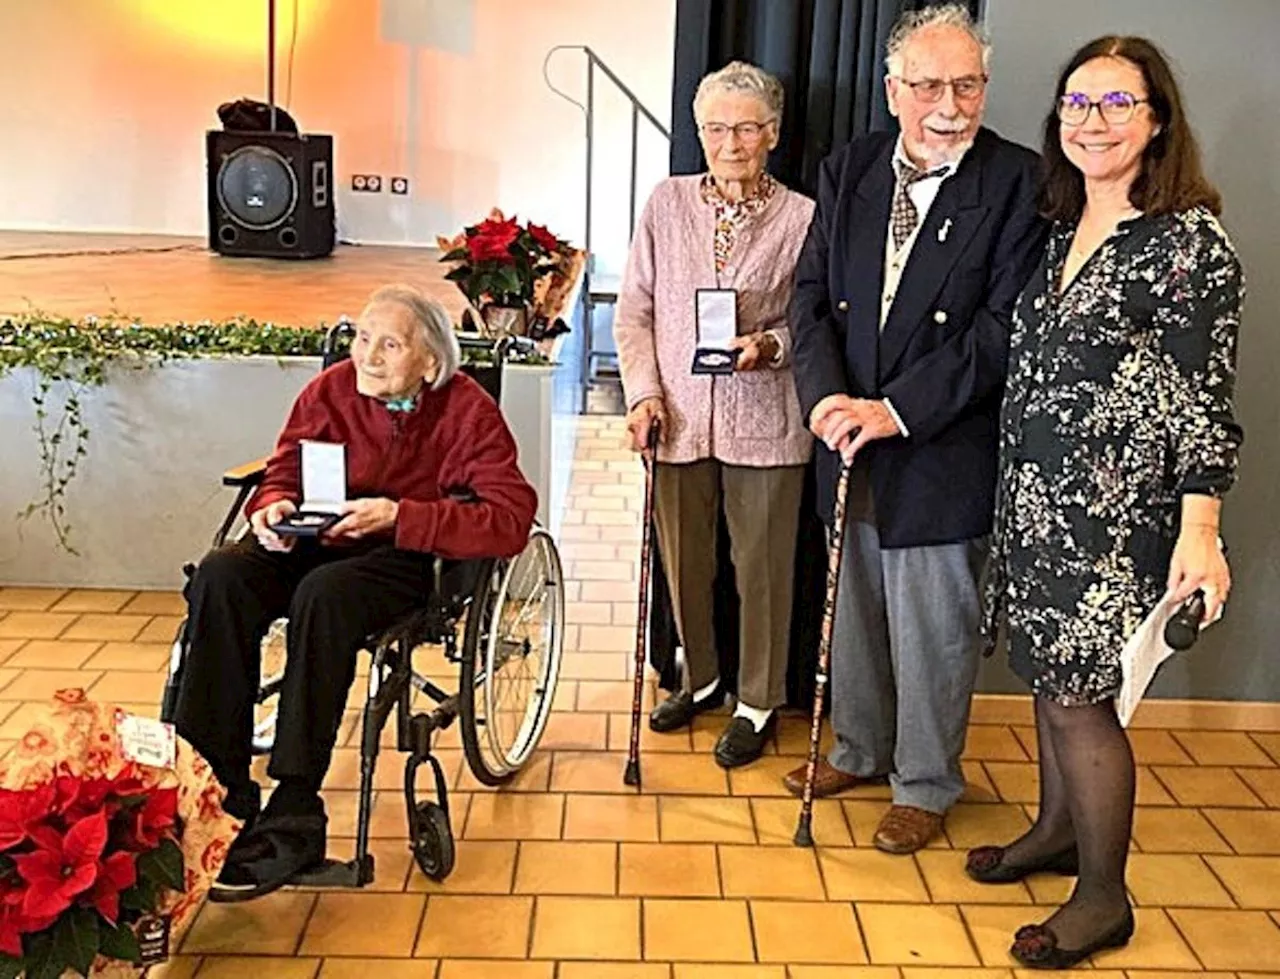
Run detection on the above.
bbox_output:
[785,4,1044,854]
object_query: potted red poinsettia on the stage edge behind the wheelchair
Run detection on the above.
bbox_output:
[436,209,577,335]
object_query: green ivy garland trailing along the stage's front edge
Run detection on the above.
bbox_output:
[0,312,548,554]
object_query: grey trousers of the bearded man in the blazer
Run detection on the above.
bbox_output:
[828,499,987,813]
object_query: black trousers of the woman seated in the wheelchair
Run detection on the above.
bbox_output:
[174,540,433,786]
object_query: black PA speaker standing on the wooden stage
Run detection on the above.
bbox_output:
[206,129,334,259]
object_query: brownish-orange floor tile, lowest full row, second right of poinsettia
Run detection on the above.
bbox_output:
[298,893,426,959]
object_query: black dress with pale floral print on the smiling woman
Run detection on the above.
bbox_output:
[983,207,1243,705]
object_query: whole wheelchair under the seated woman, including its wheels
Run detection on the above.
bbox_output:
[160,320,564,888]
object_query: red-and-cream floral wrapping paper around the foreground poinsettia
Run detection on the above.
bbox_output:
[0,690,241,979]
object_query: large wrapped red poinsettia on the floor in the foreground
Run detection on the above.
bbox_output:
[0,690,236,979]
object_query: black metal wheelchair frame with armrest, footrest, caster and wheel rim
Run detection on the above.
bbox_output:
[161,321,564,888]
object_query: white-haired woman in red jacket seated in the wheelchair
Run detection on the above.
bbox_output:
[172,287,563,901]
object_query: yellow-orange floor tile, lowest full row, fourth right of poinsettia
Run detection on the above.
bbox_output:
[532,897,640,961]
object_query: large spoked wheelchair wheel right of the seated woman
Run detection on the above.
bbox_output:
[458,527,564,786]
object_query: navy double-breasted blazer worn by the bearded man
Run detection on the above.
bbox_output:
[791,129,1048,548]
